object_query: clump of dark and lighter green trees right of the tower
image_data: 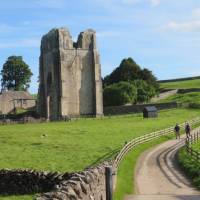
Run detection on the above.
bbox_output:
[103,58,159,106]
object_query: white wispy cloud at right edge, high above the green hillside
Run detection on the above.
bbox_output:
[162,20,200,32]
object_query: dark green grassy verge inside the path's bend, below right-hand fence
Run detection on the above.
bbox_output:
[178,147,200,189]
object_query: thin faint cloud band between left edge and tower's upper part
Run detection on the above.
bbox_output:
[0,38,40,49]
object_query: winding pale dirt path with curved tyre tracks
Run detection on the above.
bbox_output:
[125,134,200,200]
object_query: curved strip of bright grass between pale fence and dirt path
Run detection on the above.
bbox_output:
[114,136,173,200]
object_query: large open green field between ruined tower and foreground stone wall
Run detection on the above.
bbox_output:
[0,109,200,171]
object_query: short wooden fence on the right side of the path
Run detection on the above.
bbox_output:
[185,131,200,163]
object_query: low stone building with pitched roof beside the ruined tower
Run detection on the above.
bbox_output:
[0,91,36,115]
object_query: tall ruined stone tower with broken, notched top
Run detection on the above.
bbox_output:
[38,28,103,120]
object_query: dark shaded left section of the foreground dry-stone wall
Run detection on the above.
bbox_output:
[0,170,72,195]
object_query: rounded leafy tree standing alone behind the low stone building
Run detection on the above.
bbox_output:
[1,56,33,91]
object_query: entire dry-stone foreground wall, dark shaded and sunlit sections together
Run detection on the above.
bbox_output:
[0,162,110,200]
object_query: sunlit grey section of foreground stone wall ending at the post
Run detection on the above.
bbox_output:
[36,162,109,200]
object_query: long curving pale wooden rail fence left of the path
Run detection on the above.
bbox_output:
[112,117,200,189]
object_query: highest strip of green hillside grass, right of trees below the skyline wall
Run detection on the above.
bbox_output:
[160,79,200,89]
